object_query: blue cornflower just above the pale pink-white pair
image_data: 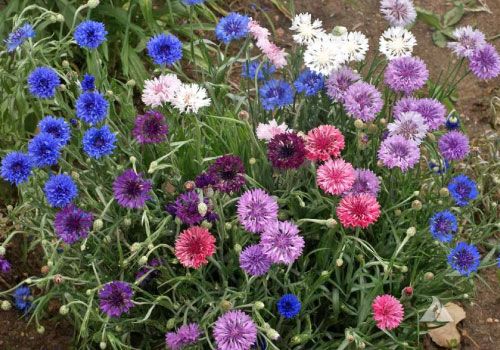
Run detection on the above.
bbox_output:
[146,33,182,65]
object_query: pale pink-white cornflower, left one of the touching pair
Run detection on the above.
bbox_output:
[142,74,182,107]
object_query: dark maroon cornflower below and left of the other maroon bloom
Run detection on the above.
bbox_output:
[207,154,245,193]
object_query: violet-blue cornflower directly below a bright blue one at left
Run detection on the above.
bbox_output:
[54,204,94,244]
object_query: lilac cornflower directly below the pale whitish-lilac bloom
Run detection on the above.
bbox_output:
[378,135,420,172]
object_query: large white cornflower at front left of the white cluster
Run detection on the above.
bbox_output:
[304,34,347,76]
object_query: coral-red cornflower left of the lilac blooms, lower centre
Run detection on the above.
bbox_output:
[175,226,215,269]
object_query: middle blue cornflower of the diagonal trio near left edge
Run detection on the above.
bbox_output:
[28,132,61,168]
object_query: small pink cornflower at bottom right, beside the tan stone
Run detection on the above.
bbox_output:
[372,294,404,330]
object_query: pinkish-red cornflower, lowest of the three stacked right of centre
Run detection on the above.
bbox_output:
[337,193,380,228]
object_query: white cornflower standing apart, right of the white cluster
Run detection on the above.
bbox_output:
[379,27,417,60]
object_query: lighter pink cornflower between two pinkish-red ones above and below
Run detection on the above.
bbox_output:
[316,159,356,195]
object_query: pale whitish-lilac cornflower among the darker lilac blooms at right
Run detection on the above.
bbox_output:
[387,112,429,145]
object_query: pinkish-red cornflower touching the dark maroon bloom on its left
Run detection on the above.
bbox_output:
[306,125,345,161]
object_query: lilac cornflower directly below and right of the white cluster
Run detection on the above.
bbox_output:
[344,81,384,122]
